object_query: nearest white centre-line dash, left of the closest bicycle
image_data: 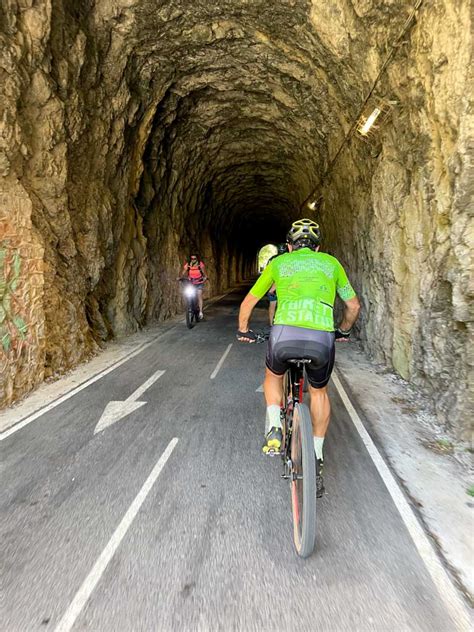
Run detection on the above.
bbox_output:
[55,438,178,632]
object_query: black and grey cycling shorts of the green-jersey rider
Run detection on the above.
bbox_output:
[265,325,335,388]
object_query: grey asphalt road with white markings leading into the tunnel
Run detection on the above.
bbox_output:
[0,294,466,632]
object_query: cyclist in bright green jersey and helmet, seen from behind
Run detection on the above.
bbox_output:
[237,219,360,497]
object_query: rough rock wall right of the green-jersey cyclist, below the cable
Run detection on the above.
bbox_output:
[320,2,474,438]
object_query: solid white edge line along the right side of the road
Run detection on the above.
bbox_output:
[332,371,471,632]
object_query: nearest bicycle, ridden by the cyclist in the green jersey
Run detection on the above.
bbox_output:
[281,358,316,557]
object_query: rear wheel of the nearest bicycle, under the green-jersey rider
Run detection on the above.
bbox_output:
[291,404,316,557]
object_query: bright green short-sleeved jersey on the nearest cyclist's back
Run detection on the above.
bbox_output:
[250,248,356,331]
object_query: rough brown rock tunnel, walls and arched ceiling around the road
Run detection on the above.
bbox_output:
[0,0,473,437]
